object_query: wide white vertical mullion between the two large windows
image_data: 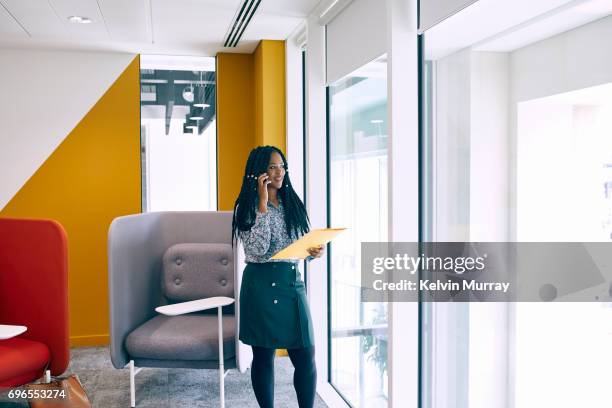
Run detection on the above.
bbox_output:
[386,0,419,408]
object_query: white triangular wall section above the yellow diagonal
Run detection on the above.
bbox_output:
[0,49,135,208]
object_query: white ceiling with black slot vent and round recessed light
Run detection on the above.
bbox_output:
[0,0,319,56]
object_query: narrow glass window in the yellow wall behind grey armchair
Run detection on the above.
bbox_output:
[140,55,217,212]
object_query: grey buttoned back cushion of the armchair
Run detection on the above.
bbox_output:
[162,243,234,302]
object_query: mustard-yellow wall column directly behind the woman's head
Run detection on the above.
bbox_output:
[217,40,287,210]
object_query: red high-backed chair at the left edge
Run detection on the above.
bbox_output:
[0,218,70,387]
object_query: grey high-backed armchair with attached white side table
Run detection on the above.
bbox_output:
[108,211,252,406]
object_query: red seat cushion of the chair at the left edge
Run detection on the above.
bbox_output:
[0,337,51,387]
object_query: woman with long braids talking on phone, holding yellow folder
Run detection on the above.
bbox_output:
[232,146,323,408]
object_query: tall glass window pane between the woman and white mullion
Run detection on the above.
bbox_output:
[328,57,388,408]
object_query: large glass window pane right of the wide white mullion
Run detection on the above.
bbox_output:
[421,1,612,408]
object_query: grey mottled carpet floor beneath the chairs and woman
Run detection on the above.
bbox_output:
[0,347,327,408]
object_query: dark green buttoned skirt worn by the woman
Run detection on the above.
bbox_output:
[239,262,314,349]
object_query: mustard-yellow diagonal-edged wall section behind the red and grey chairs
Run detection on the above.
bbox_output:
[0,57,141,345]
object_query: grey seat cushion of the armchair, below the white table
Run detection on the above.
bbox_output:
[125,314,236,360]
